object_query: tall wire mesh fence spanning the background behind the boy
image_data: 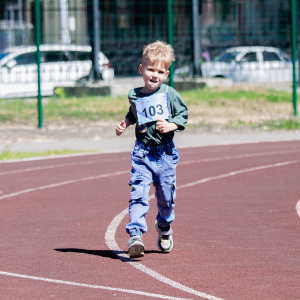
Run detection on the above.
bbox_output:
[0,0,300,127]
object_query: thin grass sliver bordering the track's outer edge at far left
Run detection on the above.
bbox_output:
[0,150,90,161]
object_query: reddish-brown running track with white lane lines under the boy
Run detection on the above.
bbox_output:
[0,141,300,299]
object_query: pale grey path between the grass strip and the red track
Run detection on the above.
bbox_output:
[0,126,300,152]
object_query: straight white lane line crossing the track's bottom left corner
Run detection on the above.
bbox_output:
[0,271,190,300]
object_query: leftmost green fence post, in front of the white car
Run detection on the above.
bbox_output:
[35,0,43,128]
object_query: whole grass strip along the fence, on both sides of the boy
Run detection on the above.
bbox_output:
[0,87,299,129]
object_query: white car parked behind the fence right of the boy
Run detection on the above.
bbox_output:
[201,46,293,83]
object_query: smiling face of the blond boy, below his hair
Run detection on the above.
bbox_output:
[139,59,170,93]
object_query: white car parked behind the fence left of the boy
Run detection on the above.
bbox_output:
[0,45,114,98]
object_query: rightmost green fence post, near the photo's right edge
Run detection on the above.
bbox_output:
[291,0,297,116]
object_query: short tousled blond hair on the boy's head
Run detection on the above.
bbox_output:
[142,41,175,69]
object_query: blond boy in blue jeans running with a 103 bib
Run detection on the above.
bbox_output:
[116,41,188,258]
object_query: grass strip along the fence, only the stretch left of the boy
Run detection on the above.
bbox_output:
[0,97,128,125]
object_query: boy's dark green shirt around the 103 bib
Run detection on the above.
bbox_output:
[126,84,188,146]
